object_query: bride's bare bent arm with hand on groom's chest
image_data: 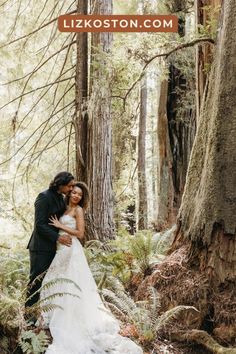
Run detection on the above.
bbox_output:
[50,207,85,240]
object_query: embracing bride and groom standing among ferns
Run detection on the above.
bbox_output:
[26,172,143,354]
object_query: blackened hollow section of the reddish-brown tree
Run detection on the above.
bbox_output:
[167,63,196,218]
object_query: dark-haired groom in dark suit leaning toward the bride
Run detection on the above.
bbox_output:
[25,172,74,307]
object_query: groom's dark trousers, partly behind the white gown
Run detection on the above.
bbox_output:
[25,251,55,307]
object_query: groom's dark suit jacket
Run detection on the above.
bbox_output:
[27,189,66,253]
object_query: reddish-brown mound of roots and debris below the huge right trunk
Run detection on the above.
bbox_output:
[135,247,236,354]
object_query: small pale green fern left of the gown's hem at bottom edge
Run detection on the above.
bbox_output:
[19,330,49,354]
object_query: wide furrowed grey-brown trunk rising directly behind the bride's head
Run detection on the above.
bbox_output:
[86,0,114,240]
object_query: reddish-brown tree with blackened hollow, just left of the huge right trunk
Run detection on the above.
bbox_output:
[157,0,196,229]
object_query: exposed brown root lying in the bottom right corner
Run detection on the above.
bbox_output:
[171,329,236,354]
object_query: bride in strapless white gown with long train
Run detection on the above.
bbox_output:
[40,182,143,354]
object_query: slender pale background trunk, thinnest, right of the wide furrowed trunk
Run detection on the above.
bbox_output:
[138,75,147,230]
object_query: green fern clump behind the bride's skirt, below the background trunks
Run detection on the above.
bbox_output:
[85,228,172,288]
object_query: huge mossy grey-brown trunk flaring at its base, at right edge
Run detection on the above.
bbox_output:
[174,0,236,282]
